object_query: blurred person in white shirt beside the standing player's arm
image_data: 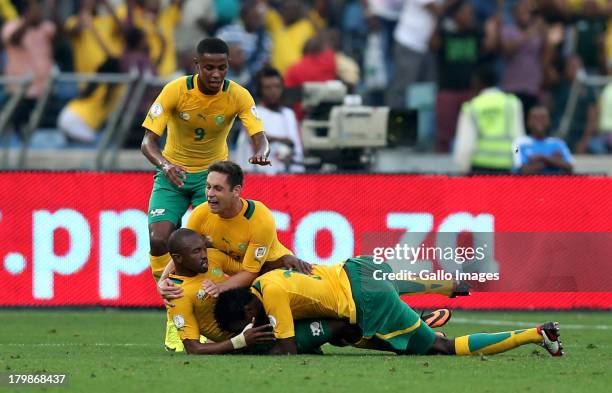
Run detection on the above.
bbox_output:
[236,67,304,175]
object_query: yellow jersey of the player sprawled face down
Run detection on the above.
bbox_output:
[251,263,357,338]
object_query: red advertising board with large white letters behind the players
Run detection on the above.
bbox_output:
[0,172,612,309]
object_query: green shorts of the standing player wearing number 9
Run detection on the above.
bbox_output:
[147,169,208,227]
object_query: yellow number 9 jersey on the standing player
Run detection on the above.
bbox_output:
[142,75,264,172]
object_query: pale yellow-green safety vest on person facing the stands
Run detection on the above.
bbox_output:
[465,91,518,169]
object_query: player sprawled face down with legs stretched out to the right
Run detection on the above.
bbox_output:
[215,257,563,356]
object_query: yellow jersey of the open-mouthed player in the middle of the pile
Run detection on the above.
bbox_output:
[187,198,291,273]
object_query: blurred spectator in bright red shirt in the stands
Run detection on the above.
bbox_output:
[285,33,336,87]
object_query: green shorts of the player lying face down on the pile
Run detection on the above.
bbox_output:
[345,257,436,355]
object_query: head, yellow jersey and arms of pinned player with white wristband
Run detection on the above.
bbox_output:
[167,228,274,354]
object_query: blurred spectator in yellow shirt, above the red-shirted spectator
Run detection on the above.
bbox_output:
[265,0,316,75]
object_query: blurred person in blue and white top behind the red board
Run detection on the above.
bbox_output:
[514,105,574,175]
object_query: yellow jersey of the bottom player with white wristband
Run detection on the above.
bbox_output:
[166,248,237,342]
